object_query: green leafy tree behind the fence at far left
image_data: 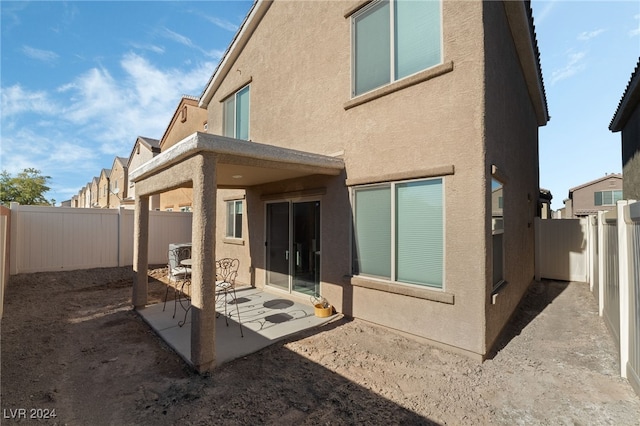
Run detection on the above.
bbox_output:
[0,168,55,206]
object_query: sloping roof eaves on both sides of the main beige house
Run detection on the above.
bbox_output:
[199,0,550,126]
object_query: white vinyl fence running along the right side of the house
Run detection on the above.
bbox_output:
[535,200,640,395]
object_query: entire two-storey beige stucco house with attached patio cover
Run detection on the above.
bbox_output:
[130,0,549,371]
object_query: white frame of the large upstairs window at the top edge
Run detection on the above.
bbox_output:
[351,0,444,98]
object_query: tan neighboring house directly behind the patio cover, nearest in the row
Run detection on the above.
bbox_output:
[160,95,207,211]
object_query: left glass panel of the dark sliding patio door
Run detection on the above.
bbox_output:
[267,202,290,291]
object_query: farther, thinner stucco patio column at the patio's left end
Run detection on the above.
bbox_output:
[131,196,149,309]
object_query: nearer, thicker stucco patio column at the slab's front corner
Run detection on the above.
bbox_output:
[191,153,216,372]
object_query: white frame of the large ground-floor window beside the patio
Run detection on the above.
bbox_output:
[350,176,447,291]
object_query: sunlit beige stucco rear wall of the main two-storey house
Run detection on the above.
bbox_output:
[208,1,516,355]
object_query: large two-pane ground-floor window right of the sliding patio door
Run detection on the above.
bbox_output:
[353,178,444,288]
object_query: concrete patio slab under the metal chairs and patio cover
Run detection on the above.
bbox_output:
[137,287,340,365]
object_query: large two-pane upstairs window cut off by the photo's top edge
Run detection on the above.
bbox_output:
[352,0,442,96]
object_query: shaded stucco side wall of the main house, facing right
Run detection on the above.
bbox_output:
[482,2,539,351]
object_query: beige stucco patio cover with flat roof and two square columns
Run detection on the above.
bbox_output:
[130,132,344,372]
